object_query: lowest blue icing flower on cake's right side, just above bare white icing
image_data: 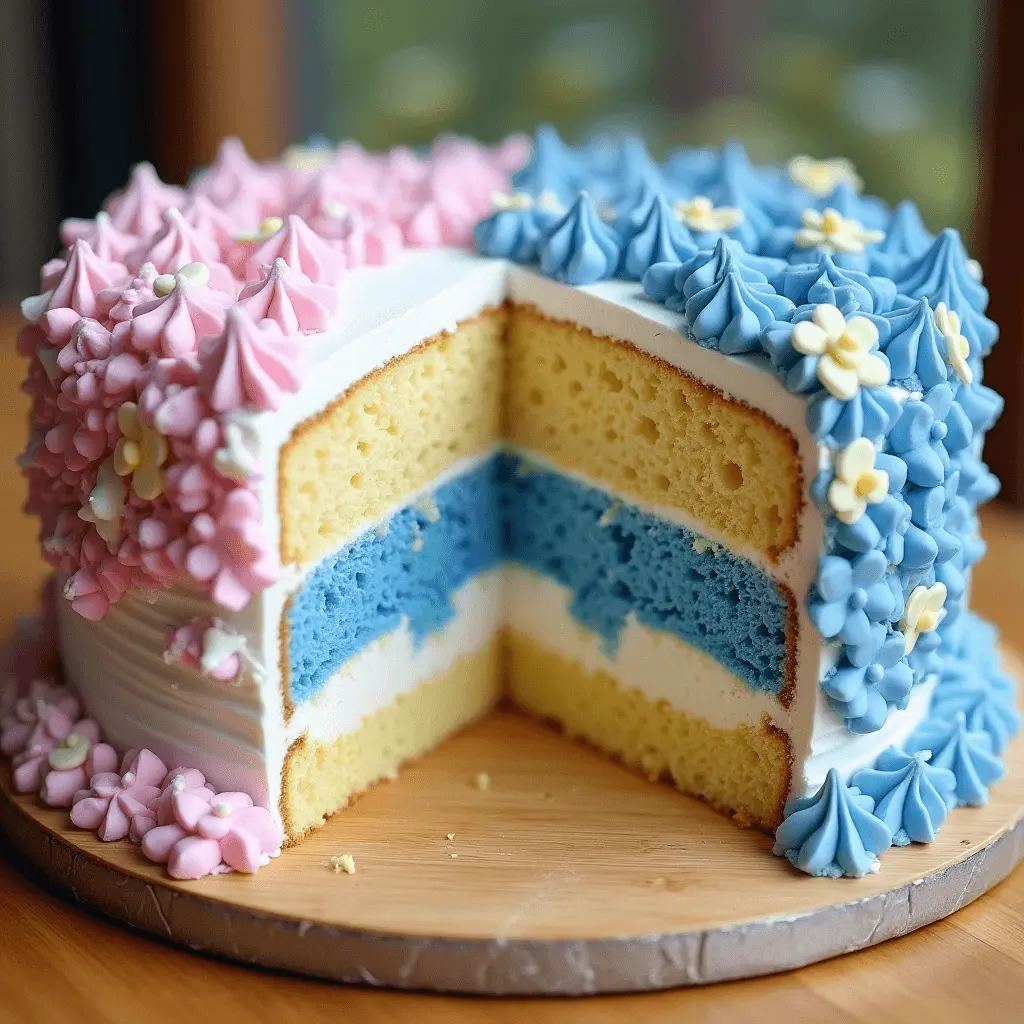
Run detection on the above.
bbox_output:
[821,633,914,733]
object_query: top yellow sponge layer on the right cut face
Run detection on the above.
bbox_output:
[506,306,803,558]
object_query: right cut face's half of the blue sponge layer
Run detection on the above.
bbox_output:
[498,456,788,693]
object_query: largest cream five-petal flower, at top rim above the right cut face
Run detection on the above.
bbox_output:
[793,303,889,401]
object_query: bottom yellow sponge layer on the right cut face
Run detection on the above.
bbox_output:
[506,633,792,829]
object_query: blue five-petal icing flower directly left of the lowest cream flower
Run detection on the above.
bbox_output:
[808,551,895,666]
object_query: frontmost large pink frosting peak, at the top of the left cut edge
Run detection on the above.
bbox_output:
[199,306,302,413]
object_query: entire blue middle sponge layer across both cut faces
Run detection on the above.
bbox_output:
[289,455,787,703]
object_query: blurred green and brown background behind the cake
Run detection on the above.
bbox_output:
[0,0,1024,500]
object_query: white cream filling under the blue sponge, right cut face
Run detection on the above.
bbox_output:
[505,567,790,731]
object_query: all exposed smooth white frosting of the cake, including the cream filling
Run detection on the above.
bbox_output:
[60,250,928,831]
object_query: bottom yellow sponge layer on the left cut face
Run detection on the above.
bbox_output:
[281,638,501,843]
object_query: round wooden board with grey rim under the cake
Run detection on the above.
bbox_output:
[0,712,1024,994]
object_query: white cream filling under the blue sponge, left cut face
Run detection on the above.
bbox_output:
[288,570,502,742]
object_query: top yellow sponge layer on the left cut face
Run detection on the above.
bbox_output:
[279,309,506,563]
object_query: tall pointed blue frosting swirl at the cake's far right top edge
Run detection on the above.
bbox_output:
[896,227,999,355]
